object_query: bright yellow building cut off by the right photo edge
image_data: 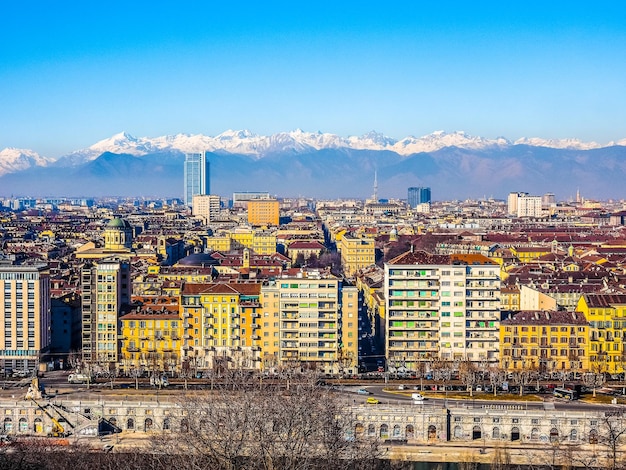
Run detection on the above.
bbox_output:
[576,294,626,374]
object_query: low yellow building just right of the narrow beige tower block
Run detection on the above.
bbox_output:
[120,310,182,373]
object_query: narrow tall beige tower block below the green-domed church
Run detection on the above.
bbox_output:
[81,258,131,366]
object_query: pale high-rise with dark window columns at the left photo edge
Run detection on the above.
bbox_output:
[0,264,51,373]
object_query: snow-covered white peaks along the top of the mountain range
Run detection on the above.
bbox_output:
[0,129,626,175]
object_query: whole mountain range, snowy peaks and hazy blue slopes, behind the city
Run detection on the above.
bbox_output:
[0,129,626,200]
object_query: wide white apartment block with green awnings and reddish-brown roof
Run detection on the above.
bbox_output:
[385,251,500,370]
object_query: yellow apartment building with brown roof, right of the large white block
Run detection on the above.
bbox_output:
[500,310,589,373]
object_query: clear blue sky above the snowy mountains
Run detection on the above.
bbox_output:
[0,0,626,156]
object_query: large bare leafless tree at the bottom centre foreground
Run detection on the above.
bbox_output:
[154,378,382,470]
